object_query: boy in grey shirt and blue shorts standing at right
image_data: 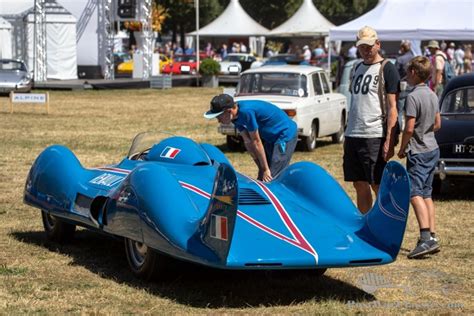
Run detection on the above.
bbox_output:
[398,56,441,259]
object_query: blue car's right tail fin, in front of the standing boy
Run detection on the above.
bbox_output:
[357,161,410,260]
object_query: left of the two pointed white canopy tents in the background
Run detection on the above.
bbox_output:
[187,0,269,55]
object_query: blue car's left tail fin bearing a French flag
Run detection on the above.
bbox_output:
[200,163,238,263]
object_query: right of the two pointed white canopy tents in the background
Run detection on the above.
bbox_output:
[268,0,334,37]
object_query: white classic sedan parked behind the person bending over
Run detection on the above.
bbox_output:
[218,65,347,151]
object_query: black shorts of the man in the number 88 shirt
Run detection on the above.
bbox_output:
[343,137,387,184]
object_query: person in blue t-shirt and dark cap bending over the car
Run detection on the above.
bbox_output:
[204,94,298,182]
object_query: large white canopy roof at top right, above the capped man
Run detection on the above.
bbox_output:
[329,0,474,41]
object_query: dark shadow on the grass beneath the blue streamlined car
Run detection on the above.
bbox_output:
[11,230,375,308]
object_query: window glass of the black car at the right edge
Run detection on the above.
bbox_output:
[441,87,474,114]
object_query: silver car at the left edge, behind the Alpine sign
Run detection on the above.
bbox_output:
[0,59,33,93]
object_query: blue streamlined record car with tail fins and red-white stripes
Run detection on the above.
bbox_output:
[24,133,409,278]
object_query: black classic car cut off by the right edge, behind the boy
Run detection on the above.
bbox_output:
[433,73,474,192]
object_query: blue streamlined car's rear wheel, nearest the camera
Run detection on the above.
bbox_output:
[125,238,166,280]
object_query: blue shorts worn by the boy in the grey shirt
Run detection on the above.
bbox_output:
[407,148,439,199]
